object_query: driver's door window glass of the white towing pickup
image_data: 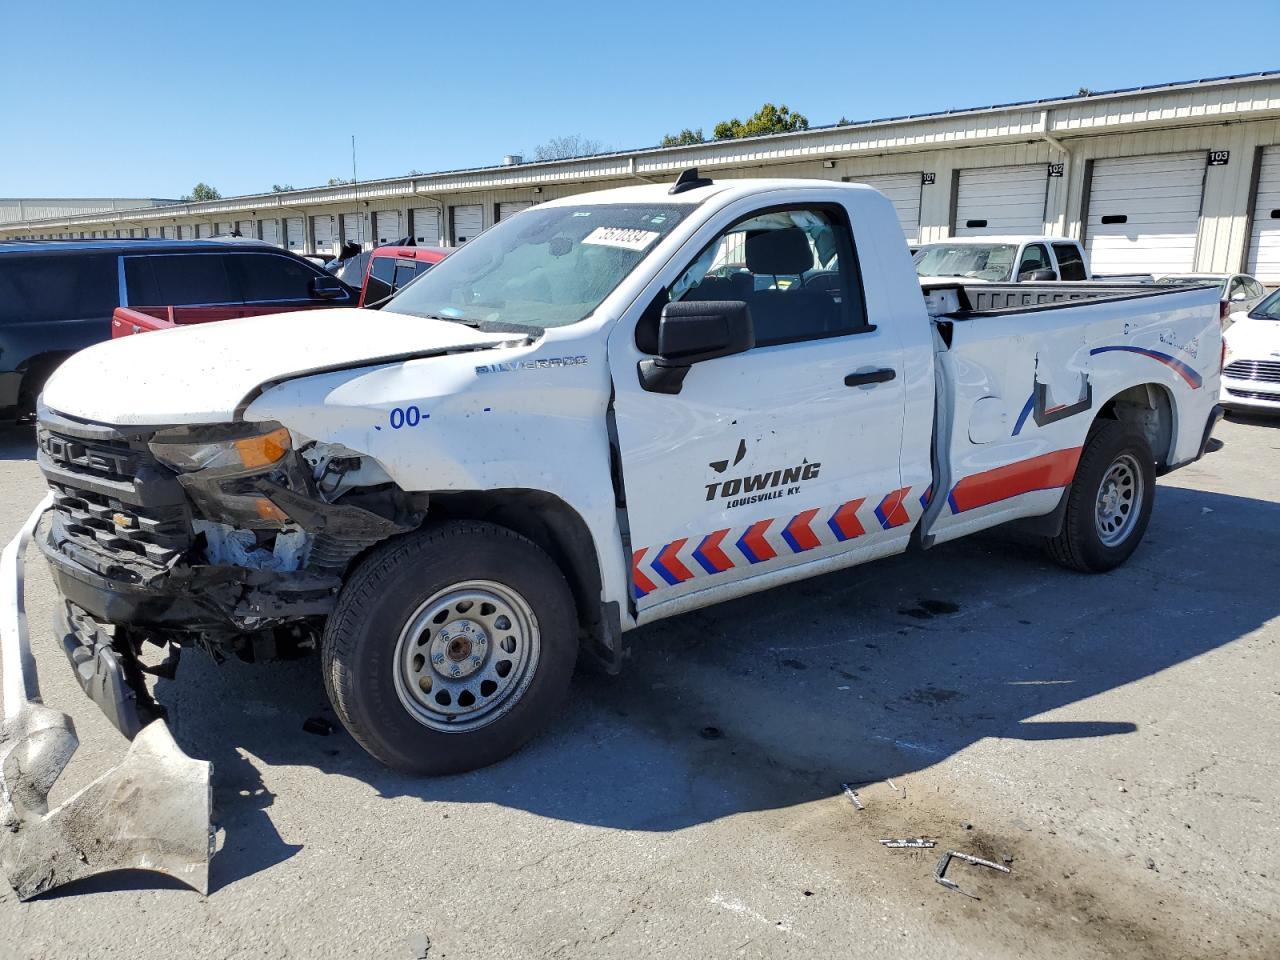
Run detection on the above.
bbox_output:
[660,209,867,352]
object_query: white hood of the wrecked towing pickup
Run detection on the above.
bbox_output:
[42,308,520,426]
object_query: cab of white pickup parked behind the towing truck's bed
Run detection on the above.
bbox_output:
[911,237,1093,283]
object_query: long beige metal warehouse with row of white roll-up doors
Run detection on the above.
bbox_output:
[0,72,1280,284]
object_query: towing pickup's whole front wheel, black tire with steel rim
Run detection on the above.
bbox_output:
[321,521,577,776]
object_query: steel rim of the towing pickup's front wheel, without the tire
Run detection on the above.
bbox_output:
[394,580,541,733]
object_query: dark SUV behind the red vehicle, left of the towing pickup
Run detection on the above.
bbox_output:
[0,239,360,420]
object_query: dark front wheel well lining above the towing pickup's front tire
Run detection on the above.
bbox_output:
[428,489,622,673]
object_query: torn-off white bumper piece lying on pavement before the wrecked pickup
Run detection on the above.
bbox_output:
[0,499,212,900]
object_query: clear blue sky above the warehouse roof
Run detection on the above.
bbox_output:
[0,0,1280,197]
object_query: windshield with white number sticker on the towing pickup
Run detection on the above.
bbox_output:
[384,204,692,328]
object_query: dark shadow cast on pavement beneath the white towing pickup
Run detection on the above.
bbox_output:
[159,485,1280,886]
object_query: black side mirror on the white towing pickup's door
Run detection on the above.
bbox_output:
[640,300,755,393]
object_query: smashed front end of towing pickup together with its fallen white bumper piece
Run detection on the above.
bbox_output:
[0,408,426,899]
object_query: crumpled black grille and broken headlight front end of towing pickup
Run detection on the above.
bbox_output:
[37,401,425,737]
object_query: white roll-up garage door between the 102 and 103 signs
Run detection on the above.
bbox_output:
[1084,151,1206,275]
